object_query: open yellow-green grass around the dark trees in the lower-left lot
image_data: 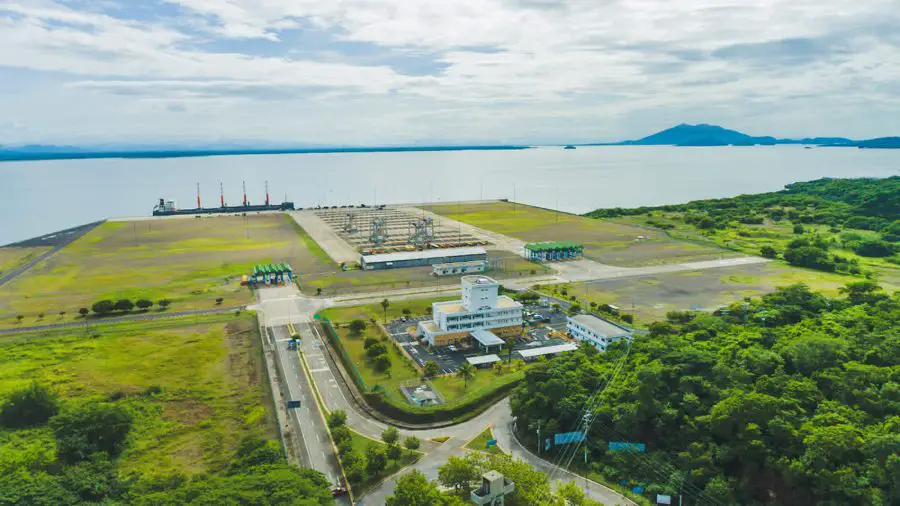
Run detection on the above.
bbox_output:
[0,313,275,476]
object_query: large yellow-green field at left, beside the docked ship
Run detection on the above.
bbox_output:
[0,215,330,326]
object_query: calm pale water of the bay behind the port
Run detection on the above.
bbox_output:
[0,146,900,245]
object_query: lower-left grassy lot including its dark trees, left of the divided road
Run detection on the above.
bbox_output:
[0,313,332,506]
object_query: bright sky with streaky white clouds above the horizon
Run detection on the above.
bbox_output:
[0,0,900,145]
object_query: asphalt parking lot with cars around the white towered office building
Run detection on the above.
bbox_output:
[385,305,566,374]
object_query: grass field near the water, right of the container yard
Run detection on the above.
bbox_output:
[425,202,733,267]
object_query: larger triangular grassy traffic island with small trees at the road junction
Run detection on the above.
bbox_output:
[328,411,422,497]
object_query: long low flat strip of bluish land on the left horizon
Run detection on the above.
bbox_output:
[0,145,529,162]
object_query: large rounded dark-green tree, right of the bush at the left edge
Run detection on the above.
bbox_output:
[50,402,132,464]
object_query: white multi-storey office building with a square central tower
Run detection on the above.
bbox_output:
[419,276,522,351]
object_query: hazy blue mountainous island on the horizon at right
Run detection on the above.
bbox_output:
[583,123,900,149]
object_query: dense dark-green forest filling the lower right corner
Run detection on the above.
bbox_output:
[511,281,900,506]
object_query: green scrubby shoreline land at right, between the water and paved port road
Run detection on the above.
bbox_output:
[587,176,900,276]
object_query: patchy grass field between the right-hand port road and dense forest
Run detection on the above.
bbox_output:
[541,262,900,325]
